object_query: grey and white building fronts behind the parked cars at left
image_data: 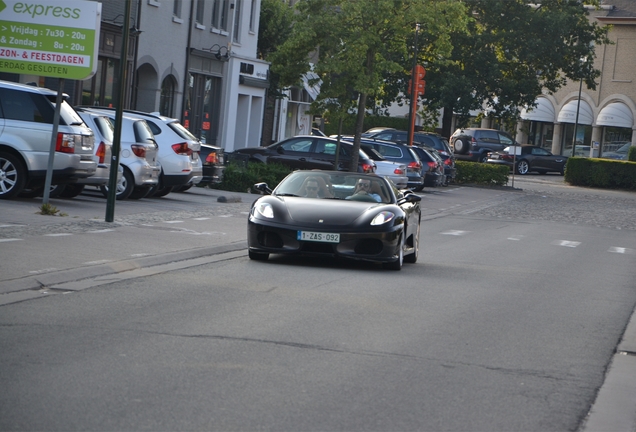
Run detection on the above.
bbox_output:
[0,0,269,152]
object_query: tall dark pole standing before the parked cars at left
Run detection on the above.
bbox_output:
[105,0,132,222]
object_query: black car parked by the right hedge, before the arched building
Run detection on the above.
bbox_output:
[486,145,568,175]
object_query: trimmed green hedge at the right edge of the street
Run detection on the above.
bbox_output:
[565,156,636,190]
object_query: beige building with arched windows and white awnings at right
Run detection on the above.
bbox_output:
[516,0,636,157]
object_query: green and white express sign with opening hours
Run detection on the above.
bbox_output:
[0,0,102,80]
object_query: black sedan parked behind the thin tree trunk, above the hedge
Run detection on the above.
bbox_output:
[233,135,375,173]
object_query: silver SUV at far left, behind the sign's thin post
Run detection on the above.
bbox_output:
[0,81,97,199]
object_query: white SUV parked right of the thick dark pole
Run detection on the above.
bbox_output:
[80,107,203,197]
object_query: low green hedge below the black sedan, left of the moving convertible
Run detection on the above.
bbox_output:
[210,162,291,193]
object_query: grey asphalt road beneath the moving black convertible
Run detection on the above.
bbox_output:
[0,177,636,431]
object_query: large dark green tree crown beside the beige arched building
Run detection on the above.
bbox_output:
[426,0,610,136]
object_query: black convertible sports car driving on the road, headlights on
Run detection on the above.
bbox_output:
[247,170,421,270]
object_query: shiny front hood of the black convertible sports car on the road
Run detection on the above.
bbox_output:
[277,197,386,226]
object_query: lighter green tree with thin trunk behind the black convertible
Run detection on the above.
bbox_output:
[271,0,467,171]
